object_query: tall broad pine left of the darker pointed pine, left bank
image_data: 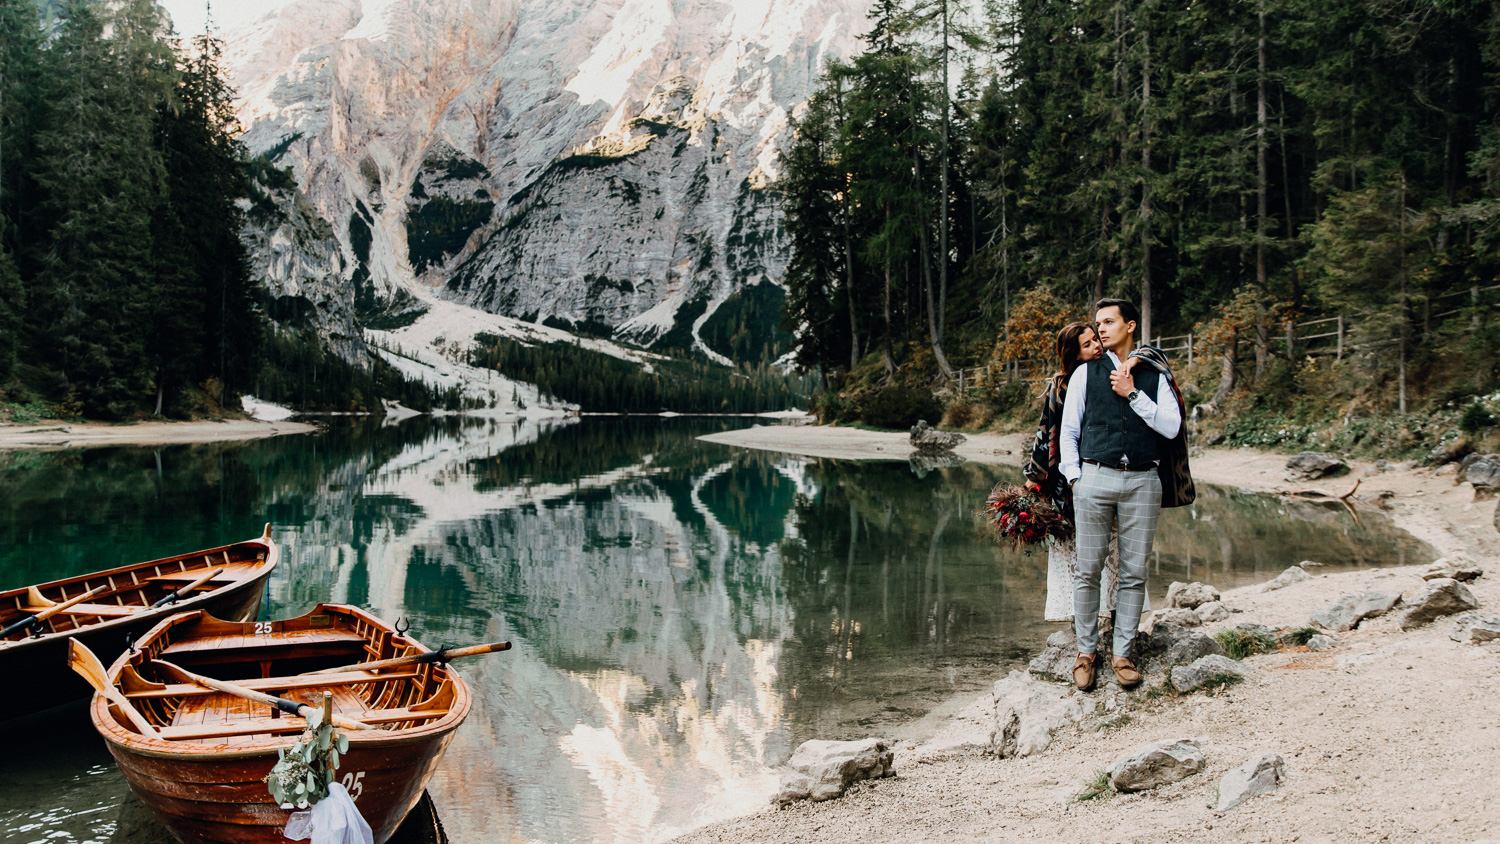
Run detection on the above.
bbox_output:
[27,0,173,418]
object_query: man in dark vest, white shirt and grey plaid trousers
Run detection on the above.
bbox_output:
[1058,298,1182,691]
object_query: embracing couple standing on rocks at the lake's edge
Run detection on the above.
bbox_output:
[1025,298,1193,691]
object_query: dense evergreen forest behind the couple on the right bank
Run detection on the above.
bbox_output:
[780,0,1500,447]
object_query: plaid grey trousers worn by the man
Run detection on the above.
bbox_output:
[1073,463,1161,657]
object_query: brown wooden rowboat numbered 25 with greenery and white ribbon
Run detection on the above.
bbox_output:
[89,604,470,844]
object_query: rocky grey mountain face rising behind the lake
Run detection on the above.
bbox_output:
[225,0,870,355]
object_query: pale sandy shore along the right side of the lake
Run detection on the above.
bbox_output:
[678,426,1500,843]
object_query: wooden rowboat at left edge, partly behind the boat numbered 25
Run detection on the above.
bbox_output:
[0,525,281,720]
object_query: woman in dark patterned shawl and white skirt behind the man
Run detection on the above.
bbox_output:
[1022,322,1149,621]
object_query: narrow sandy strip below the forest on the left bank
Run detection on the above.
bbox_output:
[0,420,318,451]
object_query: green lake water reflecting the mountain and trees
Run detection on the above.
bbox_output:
[0,417,1433,843]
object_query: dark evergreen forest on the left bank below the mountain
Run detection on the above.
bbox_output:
[0,0,461,420]
